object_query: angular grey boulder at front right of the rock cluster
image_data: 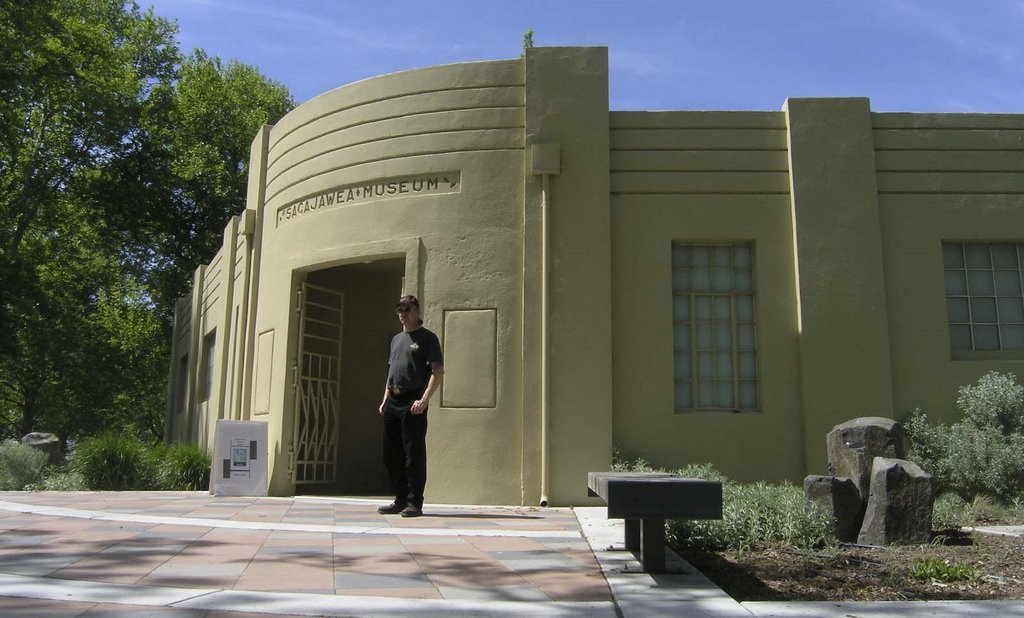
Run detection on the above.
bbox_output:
[857,457,935,545]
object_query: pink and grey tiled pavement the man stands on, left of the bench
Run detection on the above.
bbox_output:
[0,492,613,615]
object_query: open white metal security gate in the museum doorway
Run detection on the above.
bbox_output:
[294,282,344,485]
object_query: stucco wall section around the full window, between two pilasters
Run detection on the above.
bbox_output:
[611,112,804,478]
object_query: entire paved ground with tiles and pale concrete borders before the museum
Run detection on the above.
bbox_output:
[0,492,1024,618]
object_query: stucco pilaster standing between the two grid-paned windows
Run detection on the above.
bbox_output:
[783,98,893,474]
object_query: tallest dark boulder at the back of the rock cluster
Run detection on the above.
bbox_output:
[825,416,903,502]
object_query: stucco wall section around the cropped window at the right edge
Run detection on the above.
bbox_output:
[872,114,1024,423]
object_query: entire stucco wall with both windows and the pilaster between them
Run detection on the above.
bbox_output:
[611,98,1024,481]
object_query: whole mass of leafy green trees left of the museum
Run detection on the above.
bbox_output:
[0,0,294,441]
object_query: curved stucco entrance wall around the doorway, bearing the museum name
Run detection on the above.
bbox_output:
[255,56,523,503]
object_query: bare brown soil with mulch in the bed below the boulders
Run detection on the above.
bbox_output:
[677,529,1024,602]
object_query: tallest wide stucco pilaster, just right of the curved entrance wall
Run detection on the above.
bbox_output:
[523,47,611,504]
